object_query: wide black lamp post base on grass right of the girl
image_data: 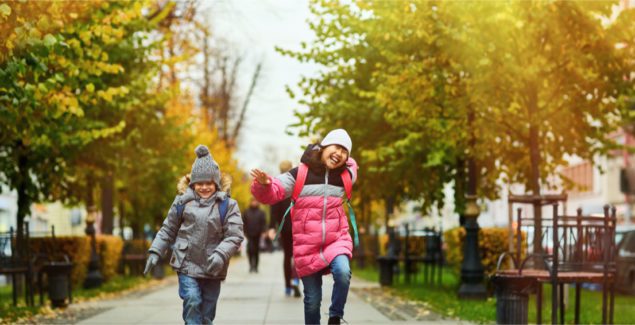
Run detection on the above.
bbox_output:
[459,195,487,299]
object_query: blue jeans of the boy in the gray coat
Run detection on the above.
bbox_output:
[179,273,220,324]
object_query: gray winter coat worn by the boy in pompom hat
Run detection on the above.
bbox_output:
[149,187,244,280]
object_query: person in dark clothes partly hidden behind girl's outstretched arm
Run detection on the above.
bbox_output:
[269,160,301,297]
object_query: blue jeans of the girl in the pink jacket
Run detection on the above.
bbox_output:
[302,255,351,324]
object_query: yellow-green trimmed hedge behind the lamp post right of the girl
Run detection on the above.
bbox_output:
[443,227,527,276]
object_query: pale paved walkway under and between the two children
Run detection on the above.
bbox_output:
[80,252,455,324]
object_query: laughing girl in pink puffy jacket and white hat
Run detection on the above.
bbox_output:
[251,129,357,324]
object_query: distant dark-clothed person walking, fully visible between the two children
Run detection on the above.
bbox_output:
[243,198,267,273]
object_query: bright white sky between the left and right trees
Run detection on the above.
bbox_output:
[208,0,317,173]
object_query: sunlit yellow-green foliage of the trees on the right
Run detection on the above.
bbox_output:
[278,1,635,220]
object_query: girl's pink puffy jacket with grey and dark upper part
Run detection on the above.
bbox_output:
[251,147,357,277]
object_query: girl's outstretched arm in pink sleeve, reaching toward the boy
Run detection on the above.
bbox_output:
[251,169,295,204]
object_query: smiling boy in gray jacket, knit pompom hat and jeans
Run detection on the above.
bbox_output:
[144,145,244,324]
